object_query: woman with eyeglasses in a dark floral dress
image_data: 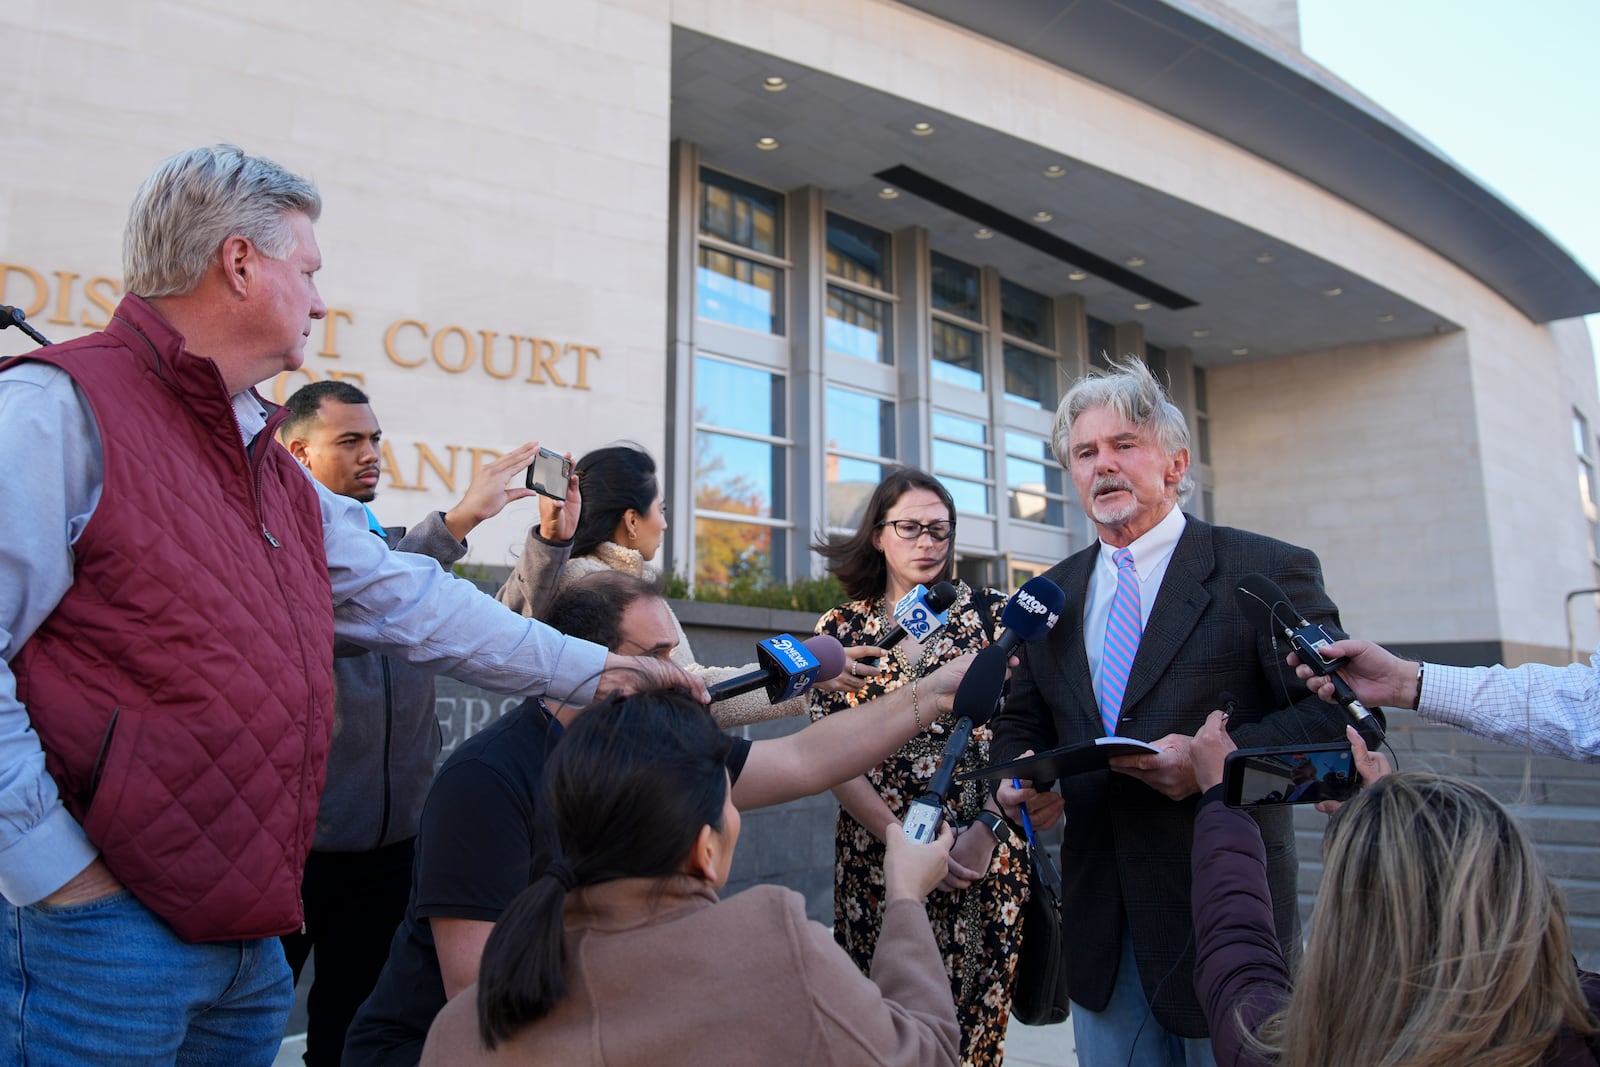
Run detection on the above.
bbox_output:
[811,467,1027,1067]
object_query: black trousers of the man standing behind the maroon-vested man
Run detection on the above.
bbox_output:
[282,838,416,1067]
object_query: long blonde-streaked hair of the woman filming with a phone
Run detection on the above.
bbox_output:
[1246,773,1597,1067]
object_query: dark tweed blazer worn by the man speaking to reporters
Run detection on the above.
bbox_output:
[990,517,1344,1037]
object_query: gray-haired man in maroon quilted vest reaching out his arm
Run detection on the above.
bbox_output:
[0,146,693,1067]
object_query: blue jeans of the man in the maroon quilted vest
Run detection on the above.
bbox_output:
[0,893,294,1067]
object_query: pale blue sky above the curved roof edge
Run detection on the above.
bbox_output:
[1299,0,1600,350]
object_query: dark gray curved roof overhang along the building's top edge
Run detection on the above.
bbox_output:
[901,0,1600,323]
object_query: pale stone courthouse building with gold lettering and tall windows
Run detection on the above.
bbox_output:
[0,0,1600,662]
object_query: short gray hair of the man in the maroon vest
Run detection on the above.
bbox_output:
[122,144,322,298]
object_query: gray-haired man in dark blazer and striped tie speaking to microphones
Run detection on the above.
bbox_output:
[992,357,1342,1067]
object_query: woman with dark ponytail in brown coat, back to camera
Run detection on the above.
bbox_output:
[422,691,960,1067]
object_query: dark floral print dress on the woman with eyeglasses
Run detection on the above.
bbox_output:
[811,584,1027,1067]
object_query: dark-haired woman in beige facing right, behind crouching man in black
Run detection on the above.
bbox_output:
[498,445,808,726]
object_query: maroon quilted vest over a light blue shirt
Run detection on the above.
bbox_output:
[11,296,333,942]
